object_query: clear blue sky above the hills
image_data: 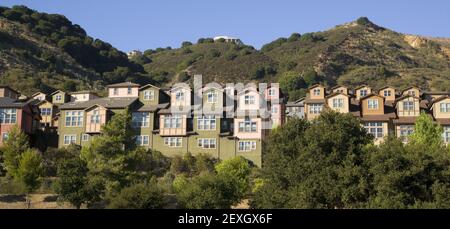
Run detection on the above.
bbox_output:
[0,0,450,51]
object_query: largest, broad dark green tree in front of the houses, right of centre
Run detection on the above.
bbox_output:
[251,111,373,208]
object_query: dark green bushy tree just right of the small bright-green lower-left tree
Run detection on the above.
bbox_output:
[55,157,102,209]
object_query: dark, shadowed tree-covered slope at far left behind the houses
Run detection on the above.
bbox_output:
[0,6,151,94]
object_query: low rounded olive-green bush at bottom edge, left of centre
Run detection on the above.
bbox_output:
[108,179,167,209]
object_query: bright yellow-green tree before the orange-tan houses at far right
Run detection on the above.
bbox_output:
[408,112,443,147]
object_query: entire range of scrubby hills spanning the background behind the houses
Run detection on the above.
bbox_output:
[0,6,450,100]
